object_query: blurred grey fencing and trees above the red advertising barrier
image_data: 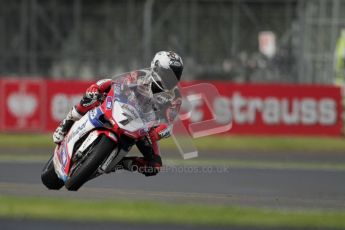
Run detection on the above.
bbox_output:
[0,0,345,84]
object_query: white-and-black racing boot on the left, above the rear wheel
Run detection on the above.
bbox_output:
[53,107,82,144]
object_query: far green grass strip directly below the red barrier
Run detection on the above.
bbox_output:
[0,134,345,152]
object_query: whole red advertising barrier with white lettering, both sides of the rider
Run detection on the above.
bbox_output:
[0,78,343,136]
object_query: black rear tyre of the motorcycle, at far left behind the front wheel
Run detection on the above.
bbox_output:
[41,155,64,190]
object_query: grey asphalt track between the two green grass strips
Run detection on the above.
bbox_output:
[0,149,345,229]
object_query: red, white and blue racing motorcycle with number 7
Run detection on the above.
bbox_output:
[41,69,180,191]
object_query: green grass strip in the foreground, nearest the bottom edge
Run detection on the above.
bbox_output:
[0,196,345,229]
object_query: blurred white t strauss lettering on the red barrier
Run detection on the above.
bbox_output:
[183,91,337,126]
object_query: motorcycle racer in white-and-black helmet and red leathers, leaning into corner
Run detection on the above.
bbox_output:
[53,51,183,176]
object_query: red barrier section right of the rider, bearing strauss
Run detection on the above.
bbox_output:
[181,82,342,136]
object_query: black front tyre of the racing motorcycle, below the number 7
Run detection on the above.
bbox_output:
[65,135,116,191]
